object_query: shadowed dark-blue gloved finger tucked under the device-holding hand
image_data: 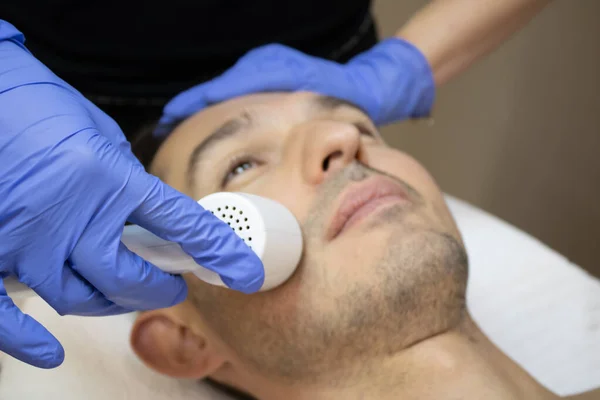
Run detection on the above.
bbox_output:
[21,261,130,316]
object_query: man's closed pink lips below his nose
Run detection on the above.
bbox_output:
[327,176,411,240]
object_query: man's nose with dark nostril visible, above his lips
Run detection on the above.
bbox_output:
[297,121,361,185]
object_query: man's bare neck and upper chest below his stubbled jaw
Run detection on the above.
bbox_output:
[237,317,558,400]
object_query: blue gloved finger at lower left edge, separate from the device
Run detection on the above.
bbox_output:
[0,280,65,368]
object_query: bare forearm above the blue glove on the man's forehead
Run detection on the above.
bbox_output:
[396,0,550,86]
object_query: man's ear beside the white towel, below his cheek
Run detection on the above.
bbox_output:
[130,309,225,379]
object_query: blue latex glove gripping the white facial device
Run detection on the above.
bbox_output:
[0,20,264,368]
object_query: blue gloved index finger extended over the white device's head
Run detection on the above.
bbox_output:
[130,175,264,293]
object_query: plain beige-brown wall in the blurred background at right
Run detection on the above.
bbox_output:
[375,0,600,276]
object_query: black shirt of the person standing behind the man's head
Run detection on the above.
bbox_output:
[0,0,370,104]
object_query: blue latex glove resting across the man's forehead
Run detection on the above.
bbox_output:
[156,38,435,135]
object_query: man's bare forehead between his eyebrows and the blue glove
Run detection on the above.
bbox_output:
[150,92,346,195]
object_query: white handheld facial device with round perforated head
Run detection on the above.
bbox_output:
[4,192,303,299]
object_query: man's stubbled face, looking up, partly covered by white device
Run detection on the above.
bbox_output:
[137,93,467,382]
